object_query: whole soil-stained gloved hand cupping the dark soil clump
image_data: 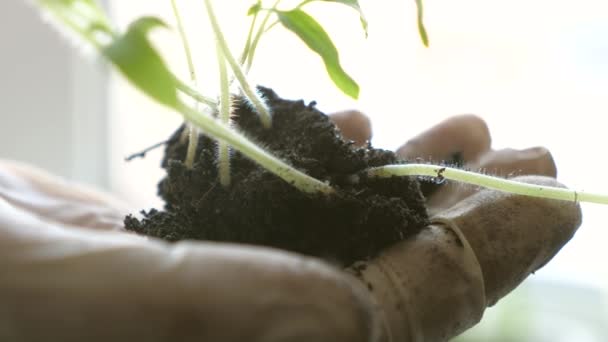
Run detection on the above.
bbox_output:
[0,113,580,342]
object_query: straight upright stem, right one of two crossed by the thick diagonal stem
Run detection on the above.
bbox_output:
[216,41,231,187]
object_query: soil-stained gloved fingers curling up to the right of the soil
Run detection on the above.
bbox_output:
[342,115,581,341]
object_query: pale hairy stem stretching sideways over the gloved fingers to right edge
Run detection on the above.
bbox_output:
[367,164,608,204]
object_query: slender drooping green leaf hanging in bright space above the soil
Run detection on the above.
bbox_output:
[276,8,359,99]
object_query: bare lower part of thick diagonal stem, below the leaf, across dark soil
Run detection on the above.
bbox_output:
[176,103,334,194]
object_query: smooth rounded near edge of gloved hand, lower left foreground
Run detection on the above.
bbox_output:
[0,162,370,342]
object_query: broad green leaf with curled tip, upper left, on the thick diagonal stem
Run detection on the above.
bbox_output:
[102,17,179,108]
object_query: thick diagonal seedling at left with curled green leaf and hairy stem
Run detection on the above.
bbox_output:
[36,0,342,194]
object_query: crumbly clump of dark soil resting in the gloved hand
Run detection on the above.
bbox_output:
[125,88,428,265]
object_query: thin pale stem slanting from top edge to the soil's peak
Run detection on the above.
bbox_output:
[205,0,272,128]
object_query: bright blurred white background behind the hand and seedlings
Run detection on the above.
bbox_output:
[0,0,608,342]
